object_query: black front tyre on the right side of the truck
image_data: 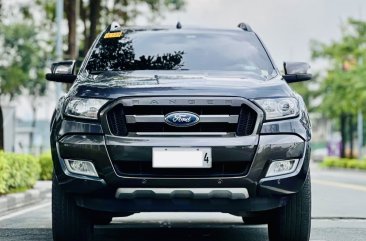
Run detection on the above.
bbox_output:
[268,172,311,241]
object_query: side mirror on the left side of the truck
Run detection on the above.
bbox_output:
[46,60,76,84]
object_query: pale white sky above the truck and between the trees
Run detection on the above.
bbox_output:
[12,0,366,119]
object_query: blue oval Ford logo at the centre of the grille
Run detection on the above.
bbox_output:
[165,112,200,127]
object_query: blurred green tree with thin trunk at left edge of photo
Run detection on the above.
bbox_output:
[0,0,52,152]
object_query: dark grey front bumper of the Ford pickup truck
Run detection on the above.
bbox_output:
[51,116,310,212]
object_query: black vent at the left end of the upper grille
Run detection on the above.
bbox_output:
[107,105,128,136]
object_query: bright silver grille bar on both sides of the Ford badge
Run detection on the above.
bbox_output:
[126,115,239,124]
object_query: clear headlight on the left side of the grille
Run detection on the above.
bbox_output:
[65,98,108,120]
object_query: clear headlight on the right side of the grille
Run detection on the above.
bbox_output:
[255,98,299,120]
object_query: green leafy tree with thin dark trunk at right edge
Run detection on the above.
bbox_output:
[312,19,366,157]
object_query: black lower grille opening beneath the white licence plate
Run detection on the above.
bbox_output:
[113,161,251,178]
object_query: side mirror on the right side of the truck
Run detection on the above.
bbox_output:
[283,62,313,83]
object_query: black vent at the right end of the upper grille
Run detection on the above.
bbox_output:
[236,105,257,136]
